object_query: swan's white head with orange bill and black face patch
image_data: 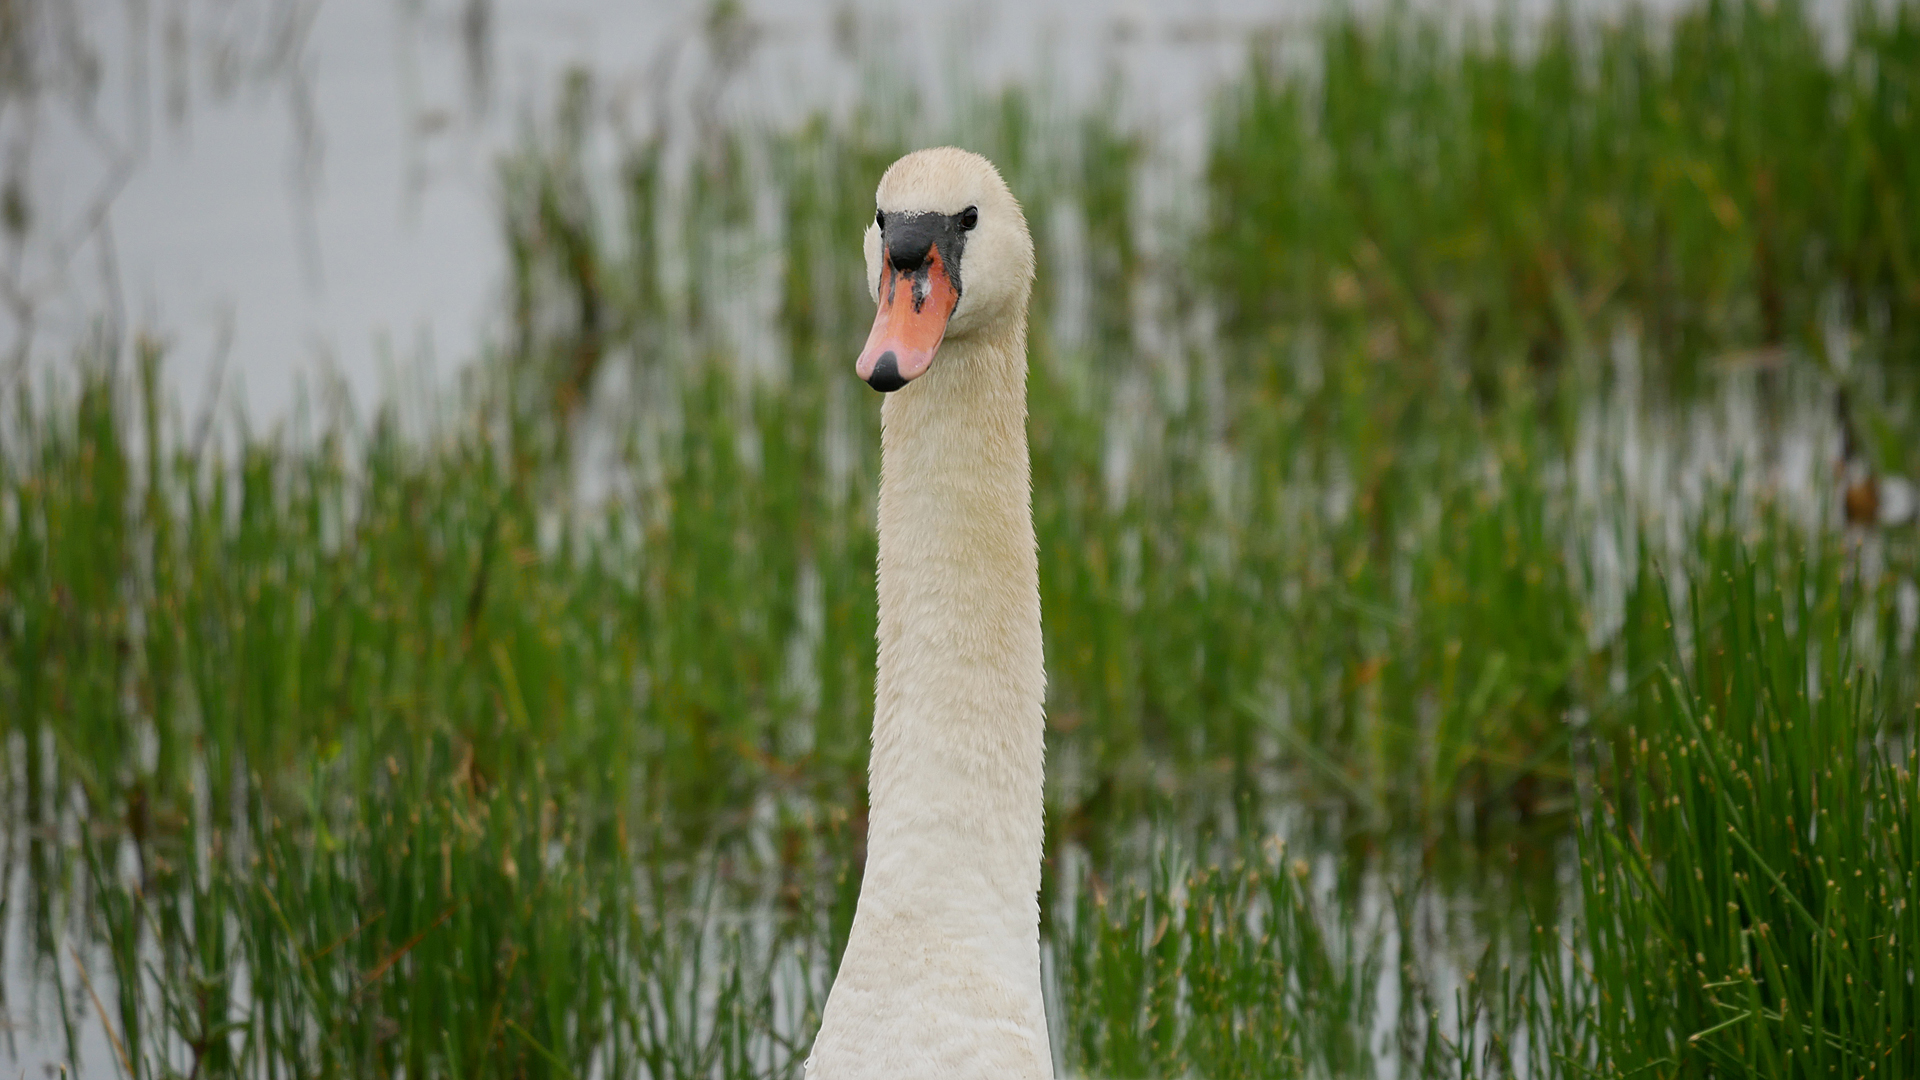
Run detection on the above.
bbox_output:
[854,146,1033,394]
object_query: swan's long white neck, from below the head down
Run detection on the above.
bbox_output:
[808,315,1052,1080]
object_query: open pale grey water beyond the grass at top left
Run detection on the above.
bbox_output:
[18,0,1367,413]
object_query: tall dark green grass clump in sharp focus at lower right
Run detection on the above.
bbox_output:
[1580,526,1920,1076]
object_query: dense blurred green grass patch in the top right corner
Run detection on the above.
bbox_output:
[1208,0,1920,386]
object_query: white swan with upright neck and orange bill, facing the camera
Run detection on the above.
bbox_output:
[804,148,1052,1080]
